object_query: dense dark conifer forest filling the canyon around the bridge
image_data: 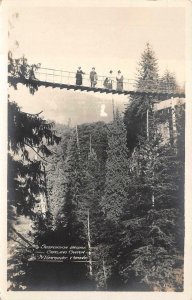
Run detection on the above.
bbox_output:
[8,44,185,292]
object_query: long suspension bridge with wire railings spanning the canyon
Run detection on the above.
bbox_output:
[8,68,185,99]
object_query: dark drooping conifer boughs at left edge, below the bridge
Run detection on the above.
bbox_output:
[8,101,60,223]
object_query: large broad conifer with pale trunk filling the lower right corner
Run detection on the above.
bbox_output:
[112,123,184,291]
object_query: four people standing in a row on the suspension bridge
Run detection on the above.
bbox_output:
[76,67,124,91]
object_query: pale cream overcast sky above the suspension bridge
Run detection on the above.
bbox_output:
[10,7,185,124]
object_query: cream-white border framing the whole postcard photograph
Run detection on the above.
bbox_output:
[0,0,192,300]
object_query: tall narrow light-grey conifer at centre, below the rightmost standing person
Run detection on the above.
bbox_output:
[102,111,128,222]
